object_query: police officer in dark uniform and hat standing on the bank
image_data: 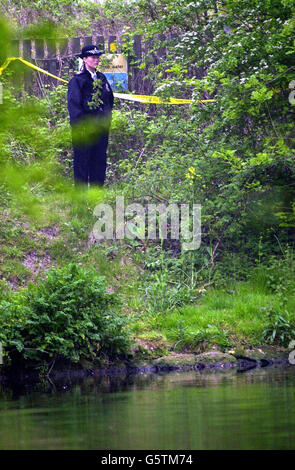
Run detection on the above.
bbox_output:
[68,45,114,186]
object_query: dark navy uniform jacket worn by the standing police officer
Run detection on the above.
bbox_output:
[68,67,114,126]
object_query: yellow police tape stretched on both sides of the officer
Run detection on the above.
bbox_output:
[0,57,216,104]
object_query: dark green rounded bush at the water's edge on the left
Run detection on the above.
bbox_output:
[0,264,130,363]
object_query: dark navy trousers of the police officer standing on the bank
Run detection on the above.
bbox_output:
[73,127,109,186]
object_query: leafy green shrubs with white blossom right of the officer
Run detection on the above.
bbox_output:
[102,0,295,282]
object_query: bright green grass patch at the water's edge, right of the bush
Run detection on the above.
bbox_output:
[150,278,295,350]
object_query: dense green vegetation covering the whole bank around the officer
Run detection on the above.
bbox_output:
[0,0,295,370]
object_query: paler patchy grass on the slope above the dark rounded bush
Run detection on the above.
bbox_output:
[0,183,146,302]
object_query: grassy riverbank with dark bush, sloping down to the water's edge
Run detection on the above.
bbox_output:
[0,188,295,375]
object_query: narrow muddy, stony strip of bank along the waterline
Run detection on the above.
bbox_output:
[0,347,290,382]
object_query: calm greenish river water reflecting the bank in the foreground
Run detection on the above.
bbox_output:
[0,365,295,450]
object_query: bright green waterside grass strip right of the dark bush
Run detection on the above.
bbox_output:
[134,279,295,349]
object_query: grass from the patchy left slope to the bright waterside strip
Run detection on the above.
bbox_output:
[0,182,295,350]
